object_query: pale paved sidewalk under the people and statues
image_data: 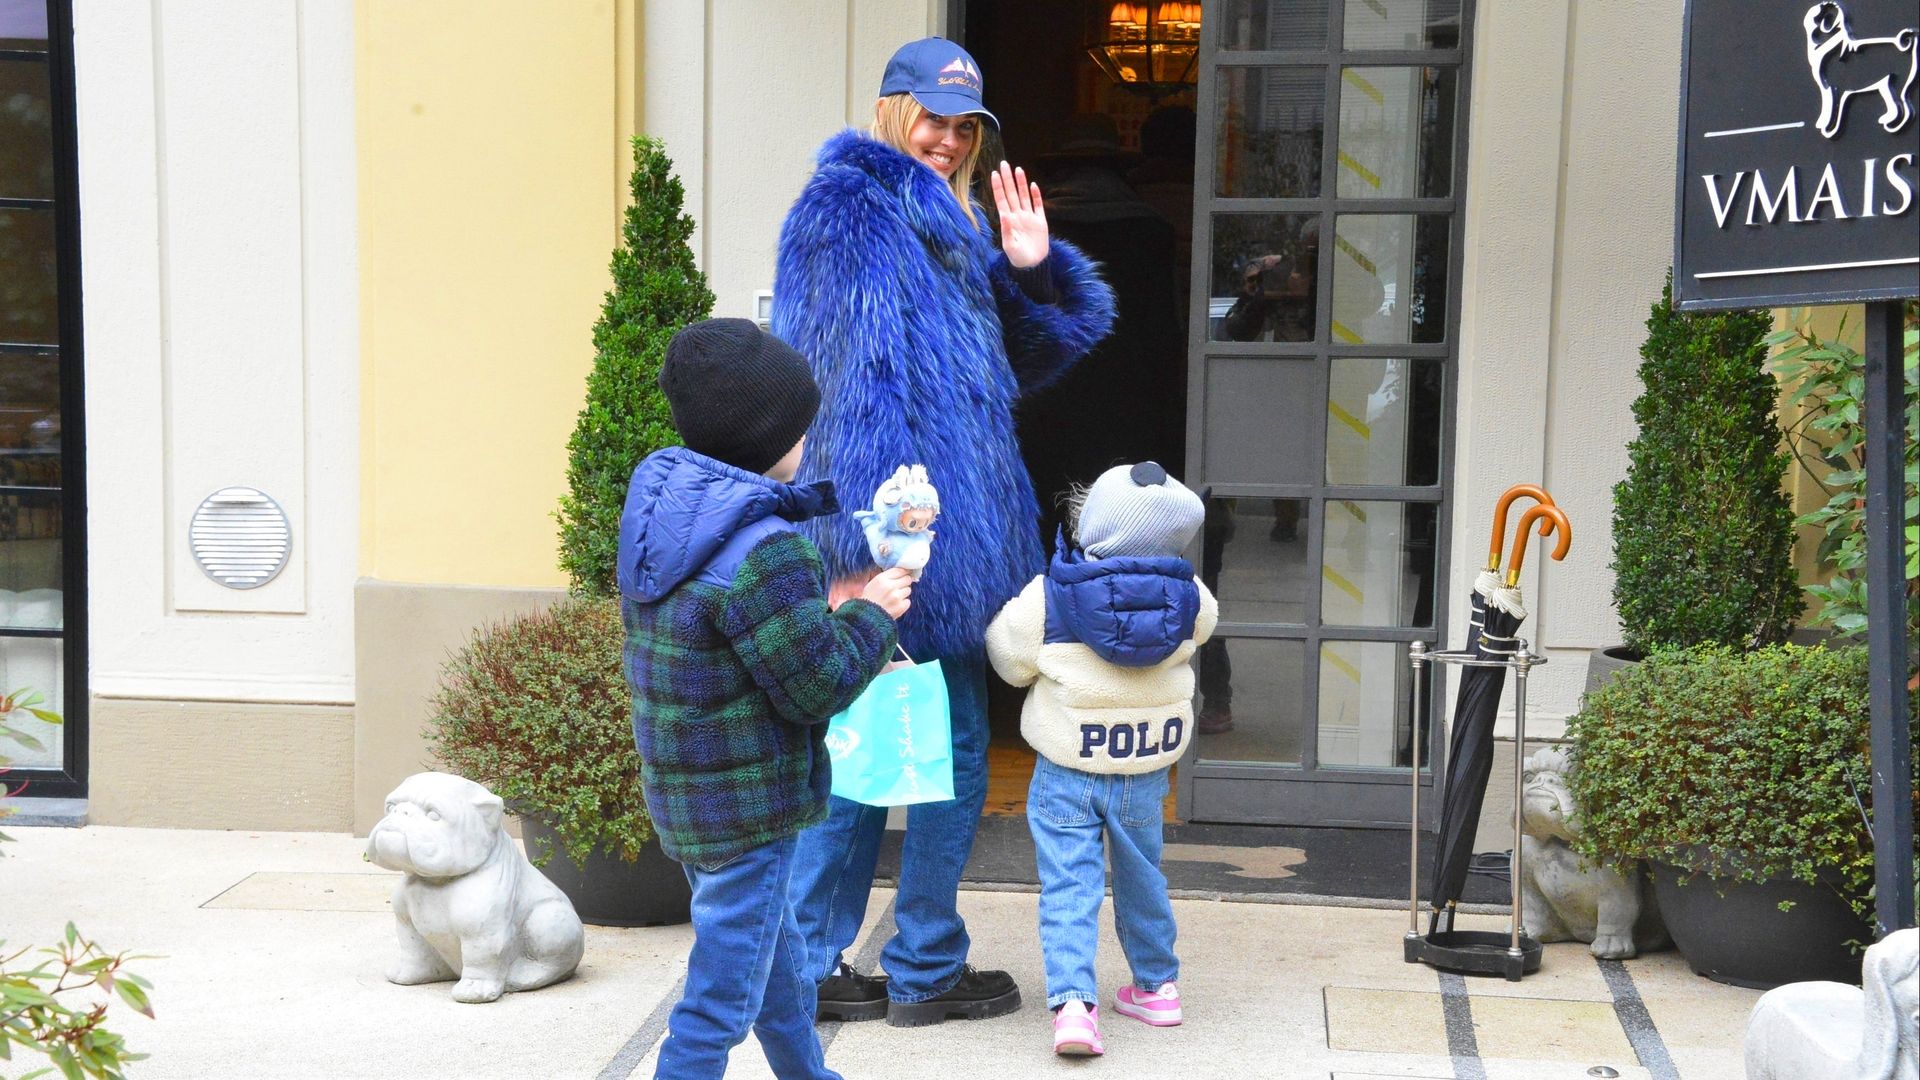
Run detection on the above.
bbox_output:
[0,826,1759,1080]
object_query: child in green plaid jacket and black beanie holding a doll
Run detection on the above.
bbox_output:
[618,319,912,1080]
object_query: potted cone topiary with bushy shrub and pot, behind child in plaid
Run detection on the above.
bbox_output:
[430,136,714,926]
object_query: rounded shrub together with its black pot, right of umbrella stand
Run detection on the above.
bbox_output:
[1567,644,1896,988]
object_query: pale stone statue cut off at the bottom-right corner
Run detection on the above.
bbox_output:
[1745,928,1920,1080]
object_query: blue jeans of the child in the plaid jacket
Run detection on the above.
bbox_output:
[653,836,841,1080]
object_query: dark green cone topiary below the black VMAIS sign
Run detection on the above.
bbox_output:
[1613,275,1803,653]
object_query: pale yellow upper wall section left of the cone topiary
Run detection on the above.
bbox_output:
[355,0,637,586]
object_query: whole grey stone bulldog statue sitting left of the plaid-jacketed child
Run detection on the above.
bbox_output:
[367,773,586,1001]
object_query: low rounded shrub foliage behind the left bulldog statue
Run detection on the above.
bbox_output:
[428,598,653,863]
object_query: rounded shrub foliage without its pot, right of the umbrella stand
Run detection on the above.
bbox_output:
[1567,646,1896,924]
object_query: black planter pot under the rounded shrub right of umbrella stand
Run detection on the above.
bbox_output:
[1647,861,1870,990]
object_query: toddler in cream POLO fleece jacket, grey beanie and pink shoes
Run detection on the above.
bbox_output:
[987,461,1219,1055]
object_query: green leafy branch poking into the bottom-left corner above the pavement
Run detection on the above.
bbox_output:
[0,922,154,1080]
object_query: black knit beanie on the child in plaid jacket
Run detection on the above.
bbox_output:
[660,319,820,473]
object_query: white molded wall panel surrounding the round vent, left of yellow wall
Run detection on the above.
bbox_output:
[75,0,359,703]
